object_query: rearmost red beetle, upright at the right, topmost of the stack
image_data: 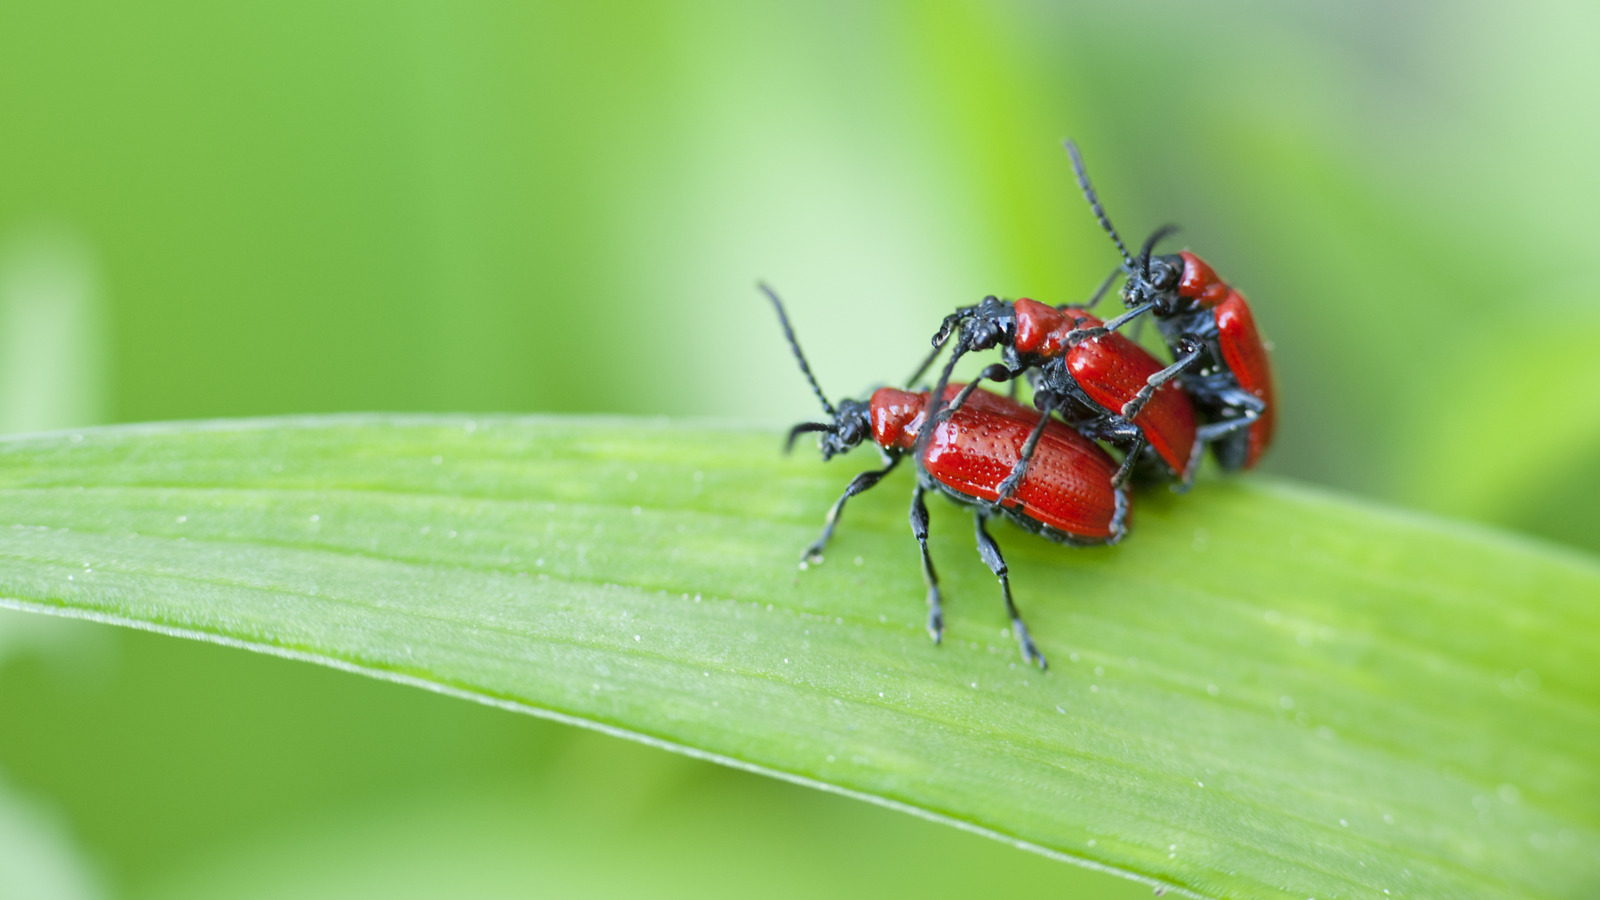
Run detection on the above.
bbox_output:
[1067,141,1277,469]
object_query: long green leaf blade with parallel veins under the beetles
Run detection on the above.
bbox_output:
[0,416,1600,898]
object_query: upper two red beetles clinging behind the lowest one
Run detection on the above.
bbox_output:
[934,141,1275,487]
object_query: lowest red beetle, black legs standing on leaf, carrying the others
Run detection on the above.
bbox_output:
[762,285,1128,668]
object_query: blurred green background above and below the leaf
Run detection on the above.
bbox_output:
[0,0,1600,897]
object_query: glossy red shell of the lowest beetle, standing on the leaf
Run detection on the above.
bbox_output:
[870,384,1118,540]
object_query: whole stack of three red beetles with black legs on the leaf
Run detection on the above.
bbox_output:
[762,141,1277,668]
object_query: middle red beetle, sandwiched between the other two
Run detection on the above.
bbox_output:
[934,296,1200,493]
